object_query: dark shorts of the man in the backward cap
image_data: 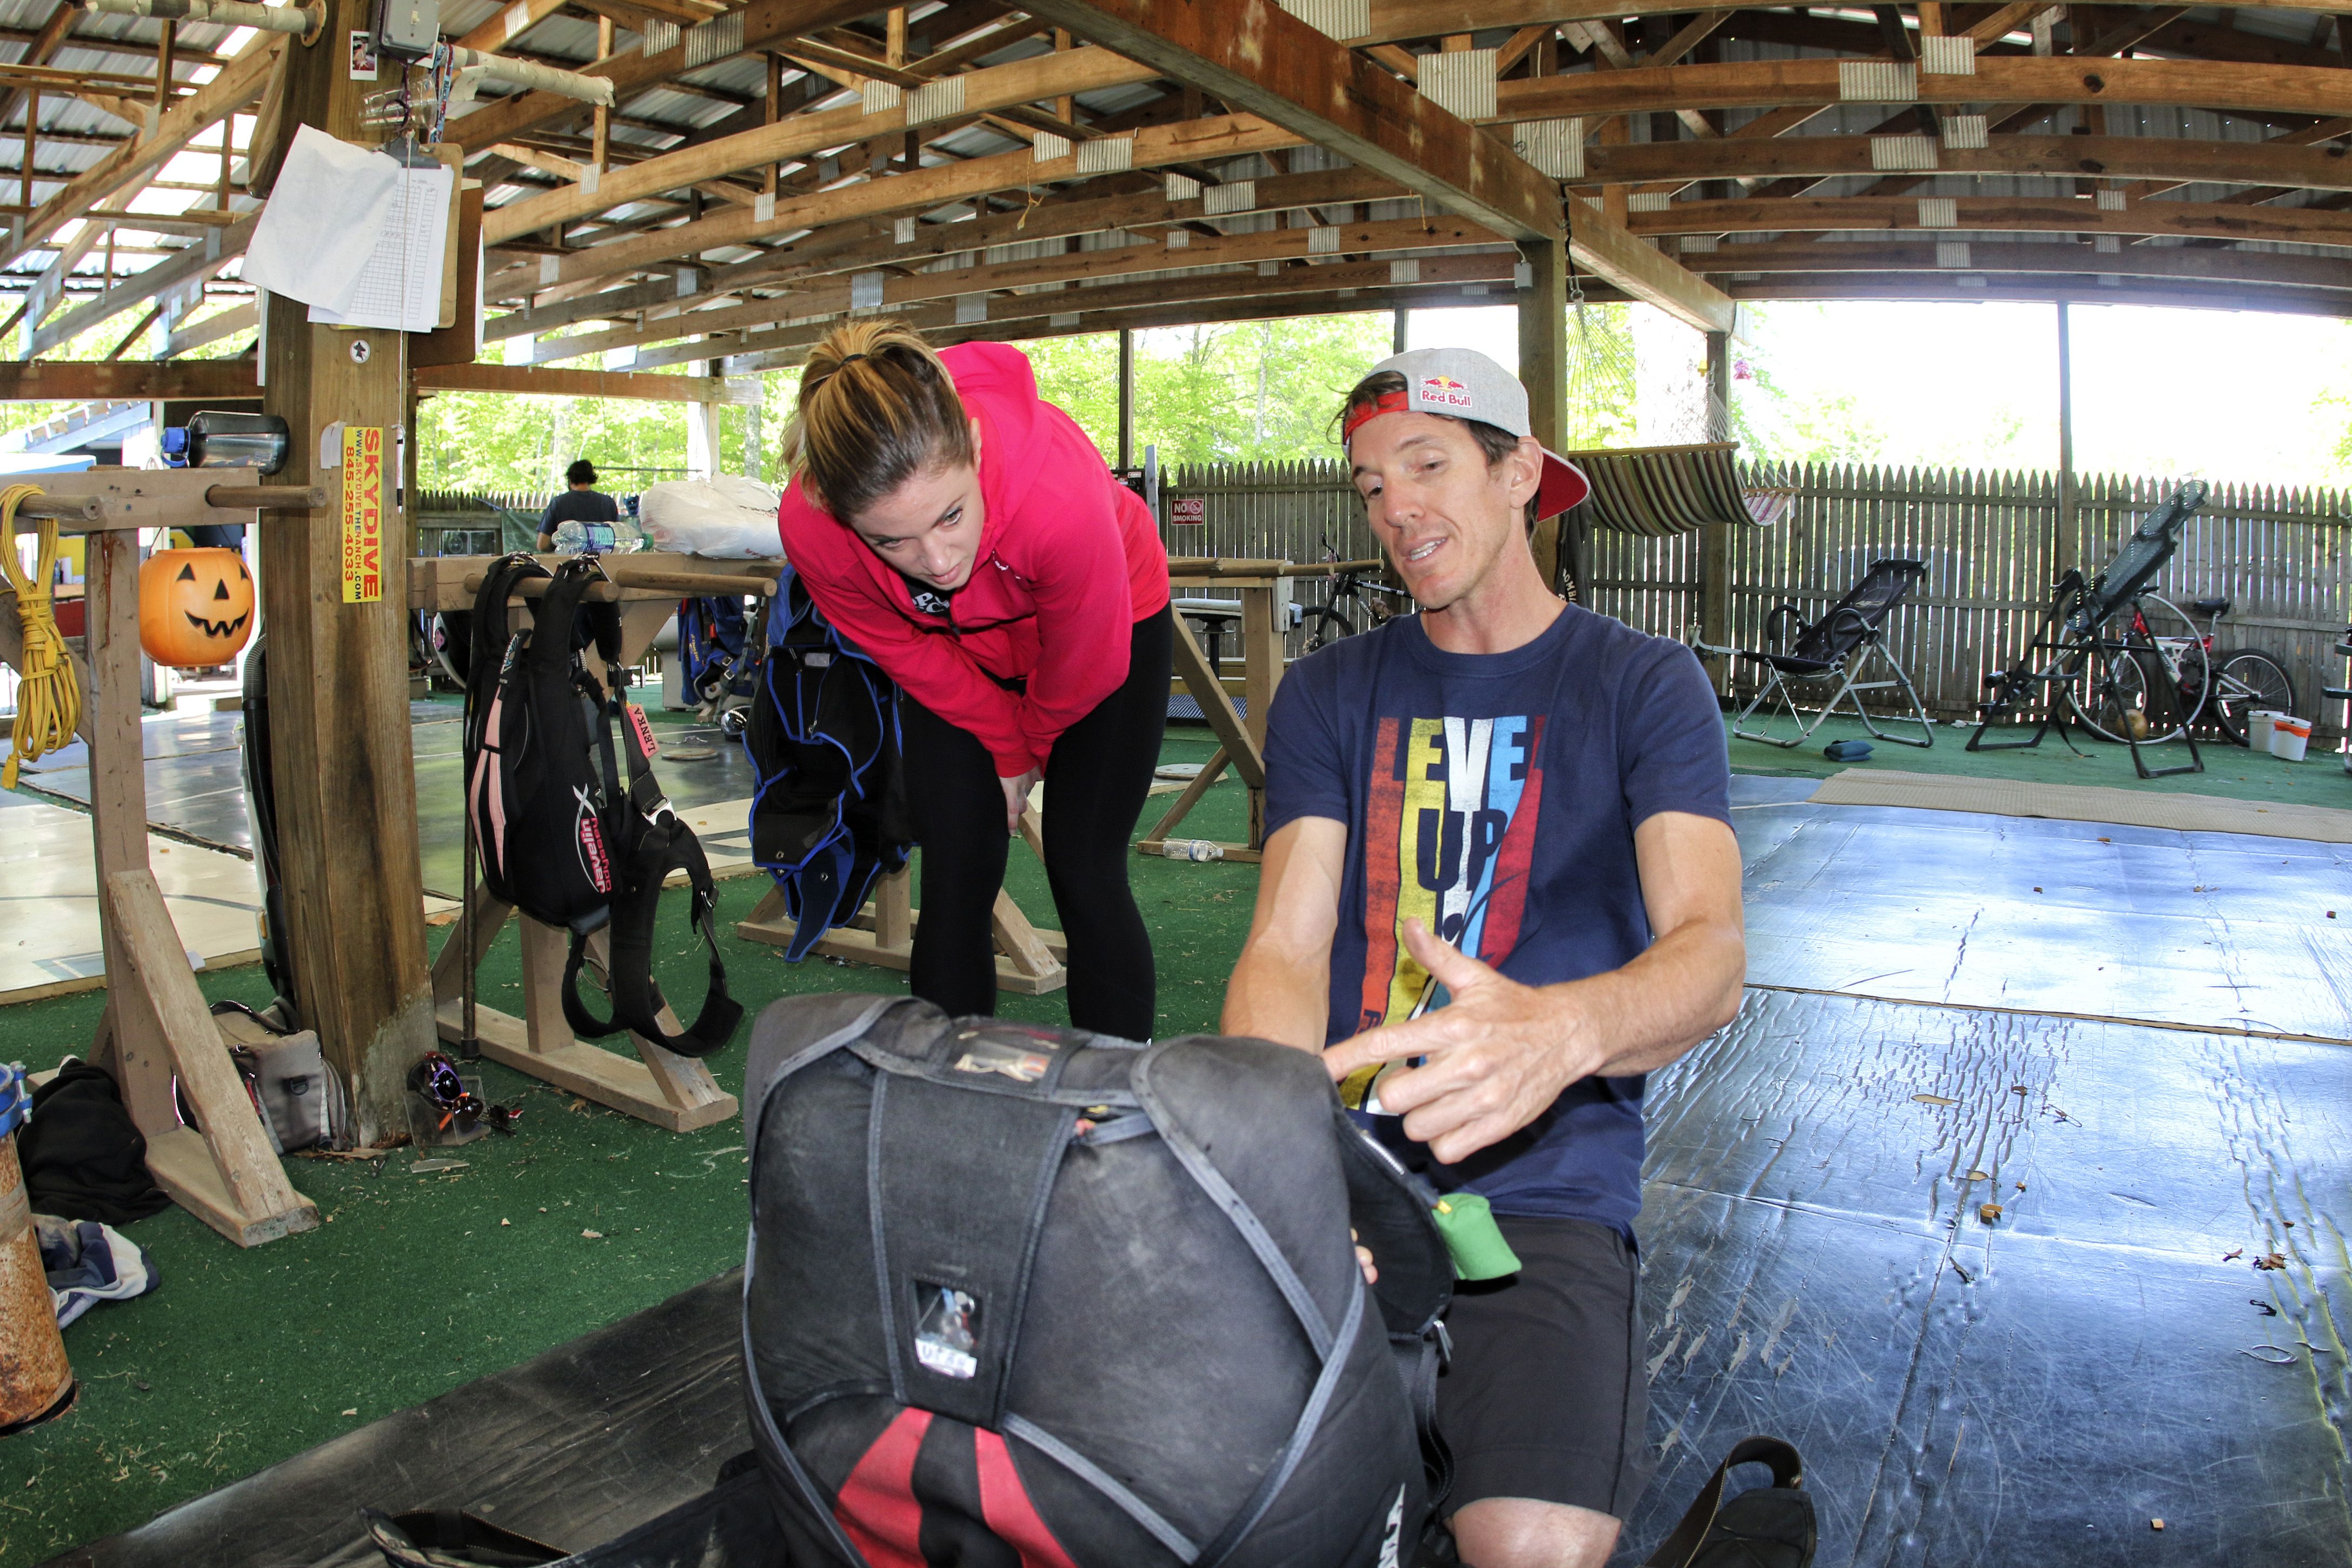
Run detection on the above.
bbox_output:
[1437,1215,1651,1519]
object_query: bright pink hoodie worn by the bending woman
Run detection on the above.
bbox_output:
[776,343,1169,778]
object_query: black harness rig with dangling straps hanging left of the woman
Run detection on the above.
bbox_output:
[466,555,743,1055]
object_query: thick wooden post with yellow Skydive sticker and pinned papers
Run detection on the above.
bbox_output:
[251,0,433,1142]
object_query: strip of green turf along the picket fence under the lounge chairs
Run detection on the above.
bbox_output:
[1724,715,2352,809]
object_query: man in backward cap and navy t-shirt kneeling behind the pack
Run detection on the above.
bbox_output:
[1223,348,1745,1568]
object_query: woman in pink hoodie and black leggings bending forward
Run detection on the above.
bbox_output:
[779,320,1174,1039]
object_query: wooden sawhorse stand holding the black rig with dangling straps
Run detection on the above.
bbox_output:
[409,553,776,1133]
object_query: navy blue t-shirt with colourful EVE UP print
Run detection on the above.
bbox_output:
[1265,604,1731,1237]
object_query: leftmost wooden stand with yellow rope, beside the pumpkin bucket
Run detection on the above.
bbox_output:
[0,468,327,1246]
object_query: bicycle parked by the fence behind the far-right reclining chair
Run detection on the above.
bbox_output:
[2065,593,2296,745]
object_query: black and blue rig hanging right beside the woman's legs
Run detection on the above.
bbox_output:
[743,567,915,964]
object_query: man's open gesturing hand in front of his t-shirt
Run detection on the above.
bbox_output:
[1324,919,1606,1164]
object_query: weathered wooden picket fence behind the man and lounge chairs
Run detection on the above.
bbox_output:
[1160,463,2352,738]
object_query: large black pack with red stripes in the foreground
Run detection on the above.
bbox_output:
[743,994,1453,1568]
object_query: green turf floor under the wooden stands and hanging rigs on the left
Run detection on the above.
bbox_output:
[0,729,1256,1568]
